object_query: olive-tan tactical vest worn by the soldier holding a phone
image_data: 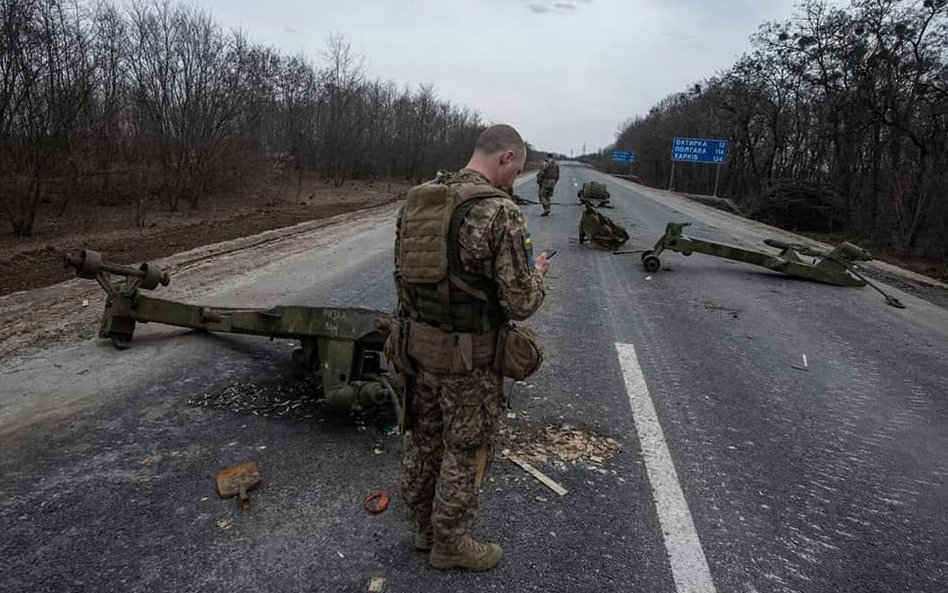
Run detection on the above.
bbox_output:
[395,174,507,333]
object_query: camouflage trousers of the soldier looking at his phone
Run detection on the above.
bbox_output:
[402,369,504,543]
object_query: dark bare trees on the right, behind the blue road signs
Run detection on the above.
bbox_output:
[591,0,948,259]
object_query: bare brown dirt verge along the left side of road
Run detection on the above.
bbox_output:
[0,172,409,366]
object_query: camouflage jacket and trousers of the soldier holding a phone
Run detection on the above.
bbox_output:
[395,169,544,549]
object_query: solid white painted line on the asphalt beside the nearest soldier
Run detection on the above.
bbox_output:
[616,342,715,593]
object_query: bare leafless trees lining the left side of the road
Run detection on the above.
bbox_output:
[0,0,485,235]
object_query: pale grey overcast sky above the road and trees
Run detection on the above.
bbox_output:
[189,0,799,155]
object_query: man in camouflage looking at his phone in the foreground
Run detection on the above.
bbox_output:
[386,125,549,570]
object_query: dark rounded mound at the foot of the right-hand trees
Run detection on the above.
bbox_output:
[751,181,848,232]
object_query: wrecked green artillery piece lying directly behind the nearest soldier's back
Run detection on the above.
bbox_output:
[64,249,399,412]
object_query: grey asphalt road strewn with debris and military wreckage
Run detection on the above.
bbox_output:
[0,165,948,593]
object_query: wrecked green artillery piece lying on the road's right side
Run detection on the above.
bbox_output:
[613,222,905,309]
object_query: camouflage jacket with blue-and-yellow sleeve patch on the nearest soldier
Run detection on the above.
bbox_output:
[395,169,545,320]
